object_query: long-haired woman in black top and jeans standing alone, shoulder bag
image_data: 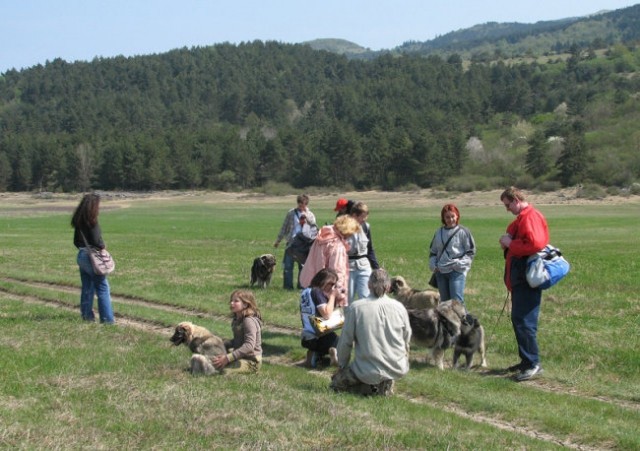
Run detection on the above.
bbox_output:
[71,194,115,324]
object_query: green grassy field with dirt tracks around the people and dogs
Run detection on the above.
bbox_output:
[0,193,640,450]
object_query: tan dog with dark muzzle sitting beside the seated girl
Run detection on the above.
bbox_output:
[169,321,226,375]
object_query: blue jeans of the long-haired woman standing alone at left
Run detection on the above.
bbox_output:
[77,249,115,324]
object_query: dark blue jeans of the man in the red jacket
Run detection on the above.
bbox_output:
[511,282,542,367]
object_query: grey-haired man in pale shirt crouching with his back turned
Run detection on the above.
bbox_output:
[331,269,411,396]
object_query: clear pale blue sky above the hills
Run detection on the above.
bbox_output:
[0,0,638,73]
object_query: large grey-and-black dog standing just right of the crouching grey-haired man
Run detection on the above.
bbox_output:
[407,300,467,370]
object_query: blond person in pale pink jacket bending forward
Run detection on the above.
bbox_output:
[300,215,360,307]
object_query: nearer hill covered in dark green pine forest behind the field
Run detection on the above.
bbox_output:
[0,26,640,191]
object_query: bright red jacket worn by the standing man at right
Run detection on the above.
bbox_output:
[504,205,549,291]
